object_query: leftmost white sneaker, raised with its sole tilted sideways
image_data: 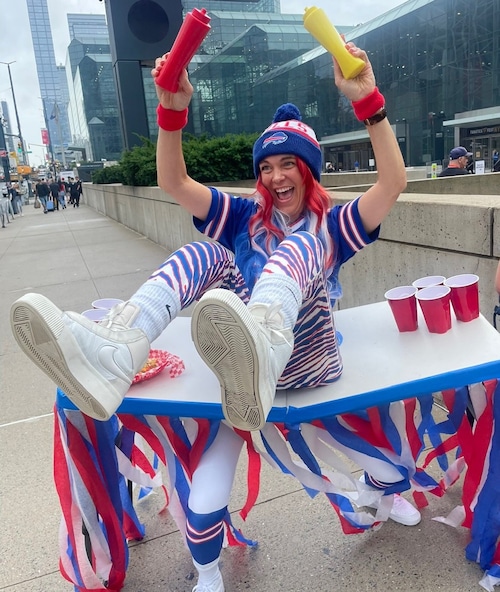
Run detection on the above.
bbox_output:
[10,294,149,420]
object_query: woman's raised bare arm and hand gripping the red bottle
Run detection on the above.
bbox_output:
[151,56,212,220]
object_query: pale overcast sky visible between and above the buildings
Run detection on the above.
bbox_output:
[0,0,404,166]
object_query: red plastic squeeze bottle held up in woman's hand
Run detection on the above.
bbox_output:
[156,8,211,92]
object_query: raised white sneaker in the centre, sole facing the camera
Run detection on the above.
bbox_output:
[191,288,293,430]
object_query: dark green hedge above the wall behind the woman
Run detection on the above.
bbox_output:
[92,134,258,187]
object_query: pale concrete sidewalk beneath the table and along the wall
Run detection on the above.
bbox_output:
[0,205,482,592]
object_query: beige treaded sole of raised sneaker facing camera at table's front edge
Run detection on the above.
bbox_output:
[191,289,266,431]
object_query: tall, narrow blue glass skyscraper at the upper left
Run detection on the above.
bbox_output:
[26,0,71,159]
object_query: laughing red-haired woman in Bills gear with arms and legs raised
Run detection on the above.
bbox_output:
[11,43,414,592]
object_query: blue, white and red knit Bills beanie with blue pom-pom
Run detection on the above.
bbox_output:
[253,103,322,181]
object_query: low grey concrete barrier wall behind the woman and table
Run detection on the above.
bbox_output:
[83,183,500,320]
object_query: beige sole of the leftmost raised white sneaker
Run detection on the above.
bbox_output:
[10,294,121,421]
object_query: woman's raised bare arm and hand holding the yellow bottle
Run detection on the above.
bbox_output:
[333,43,406,232]
